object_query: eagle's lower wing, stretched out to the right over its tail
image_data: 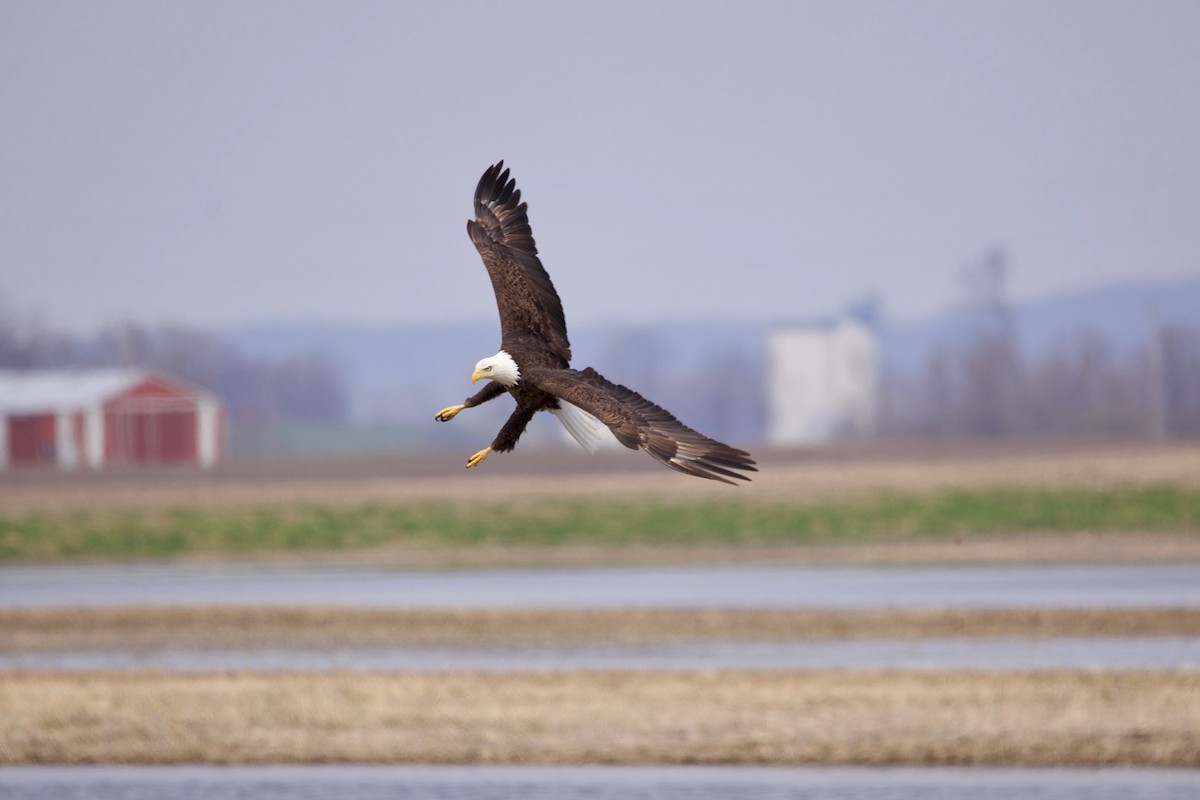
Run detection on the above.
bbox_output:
[521,367,758,483]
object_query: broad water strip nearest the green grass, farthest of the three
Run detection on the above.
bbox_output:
[0,564,1200,609]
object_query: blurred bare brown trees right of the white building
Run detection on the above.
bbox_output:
[877,325,1200,440]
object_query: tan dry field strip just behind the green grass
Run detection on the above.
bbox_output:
[0,444,1200,515]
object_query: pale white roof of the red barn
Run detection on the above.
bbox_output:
[0,369,150,414]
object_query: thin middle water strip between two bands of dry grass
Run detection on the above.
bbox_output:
[9,637,1200,672]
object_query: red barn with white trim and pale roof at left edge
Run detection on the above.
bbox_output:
[0,369,221,469]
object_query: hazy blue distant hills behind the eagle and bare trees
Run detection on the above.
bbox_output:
[220,277,1200,441]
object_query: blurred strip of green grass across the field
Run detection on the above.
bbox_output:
[0,486,1200,561]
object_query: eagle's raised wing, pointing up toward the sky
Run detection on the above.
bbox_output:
[467,161,571,365]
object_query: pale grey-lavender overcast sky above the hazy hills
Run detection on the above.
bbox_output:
[0,0,1200,332]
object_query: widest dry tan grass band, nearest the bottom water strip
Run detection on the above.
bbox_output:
[0,672,1200,768]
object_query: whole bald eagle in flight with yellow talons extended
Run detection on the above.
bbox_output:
[436,161,757,483]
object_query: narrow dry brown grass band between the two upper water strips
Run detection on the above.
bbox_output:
[7,607,1200,652]
